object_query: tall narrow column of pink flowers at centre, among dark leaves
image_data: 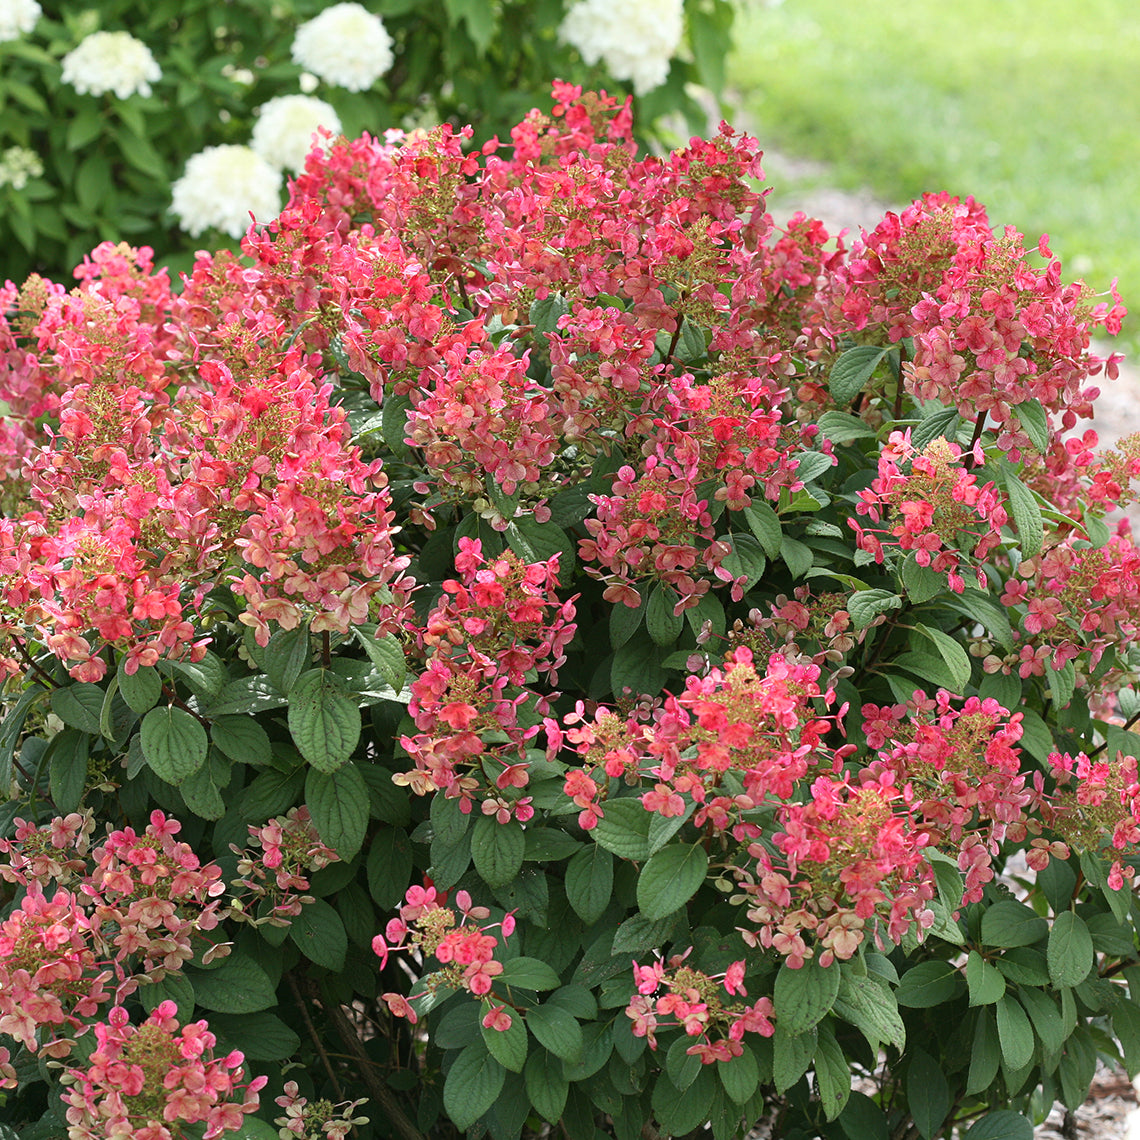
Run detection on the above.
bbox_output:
[396,538,577,823]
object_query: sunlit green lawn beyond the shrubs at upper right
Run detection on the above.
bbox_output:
[728,0,1140,359]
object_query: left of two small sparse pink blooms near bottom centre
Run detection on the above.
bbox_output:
[372,885,514,1032]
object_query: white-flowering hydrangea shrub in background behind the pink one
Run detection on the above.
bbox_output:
[0,0,733,282]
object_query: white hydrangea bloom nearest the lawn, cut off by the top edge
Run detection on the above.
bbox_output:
[559,0,685,95]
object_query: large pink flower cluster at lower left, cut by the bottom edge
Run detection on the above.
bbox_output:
[64,1001,269,1140]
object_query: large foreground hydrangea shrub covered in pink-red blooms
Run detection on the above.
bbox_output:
[0,84,1140,1140]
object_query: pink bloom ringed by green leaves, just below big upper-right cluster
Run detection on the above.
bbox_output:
[848,430,1009,594]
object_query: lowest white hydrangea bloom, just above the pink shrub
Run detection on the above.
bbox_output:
[171,146,282,237]
